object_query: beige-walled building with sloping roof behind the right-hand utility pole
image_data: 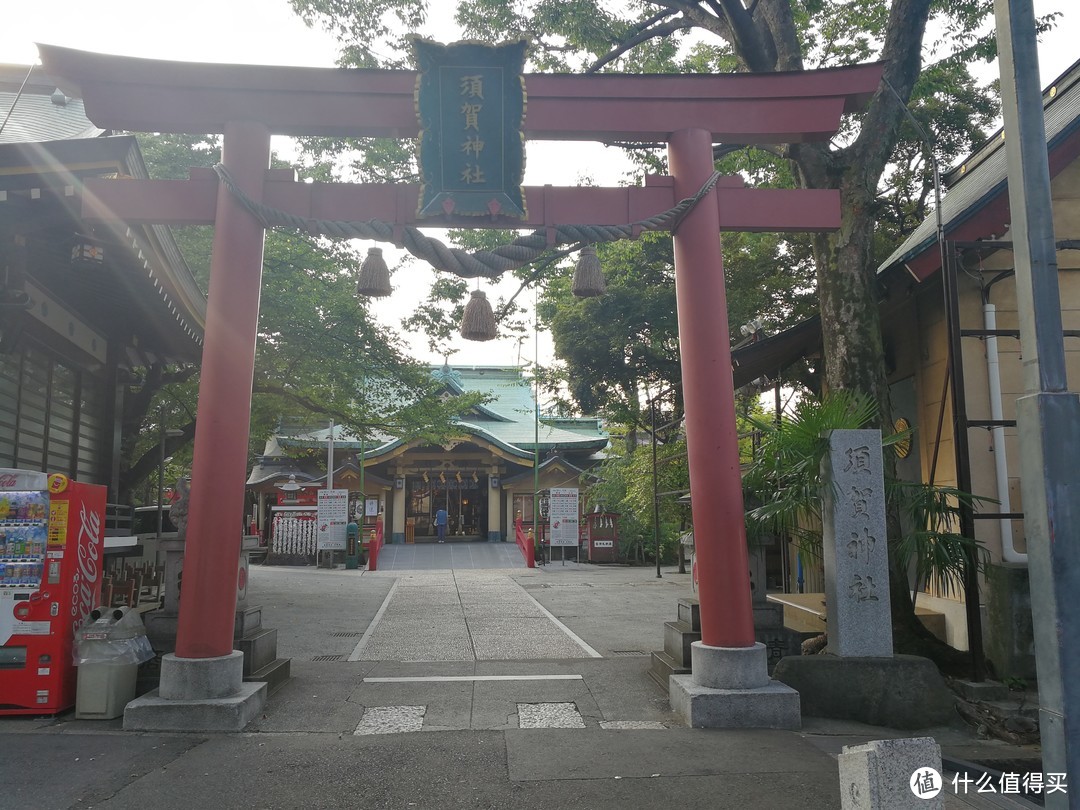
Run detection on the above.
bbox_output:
[879,57,1080,677]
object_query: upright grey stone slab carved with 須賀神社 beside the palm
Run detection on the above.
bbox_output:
[822,430,892,658]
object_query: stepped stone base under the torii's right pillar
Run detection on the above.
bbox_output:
[667,642,801,729]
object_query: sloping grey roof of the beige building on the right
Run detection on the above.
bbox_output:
[878,62,1080,273]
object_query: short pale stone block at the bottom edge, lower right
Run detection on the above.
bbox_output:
[839,737,945,810]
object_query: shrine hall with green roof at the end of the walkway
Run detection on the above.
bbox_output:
[247,365,608,553]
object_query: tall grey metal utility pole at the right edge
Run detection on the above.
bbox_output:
[994,0,1080,808]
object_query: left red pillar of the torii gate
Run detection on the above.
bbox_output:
[176,121,270,659]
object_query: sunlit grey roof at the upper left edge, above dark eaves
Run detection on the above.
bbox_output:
[0,65,106,144]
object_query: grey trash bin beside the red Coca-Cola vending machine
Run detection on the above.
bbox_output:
[72,607,153,720]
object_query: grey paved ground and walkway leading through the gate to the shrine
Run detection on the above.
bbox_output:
[0,557,1045,809]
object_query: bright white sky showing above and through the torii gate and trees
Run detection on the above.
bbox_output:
[0,0,1080,365]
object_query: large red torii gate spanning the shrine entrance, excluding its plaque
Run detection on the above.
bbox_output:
[39,45,882,728]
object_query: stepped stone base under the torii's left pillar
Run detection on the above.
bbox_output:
[124,650,267,731]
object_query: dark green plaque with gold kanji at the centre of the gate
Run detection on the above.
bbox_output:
[413,39,526,218]
